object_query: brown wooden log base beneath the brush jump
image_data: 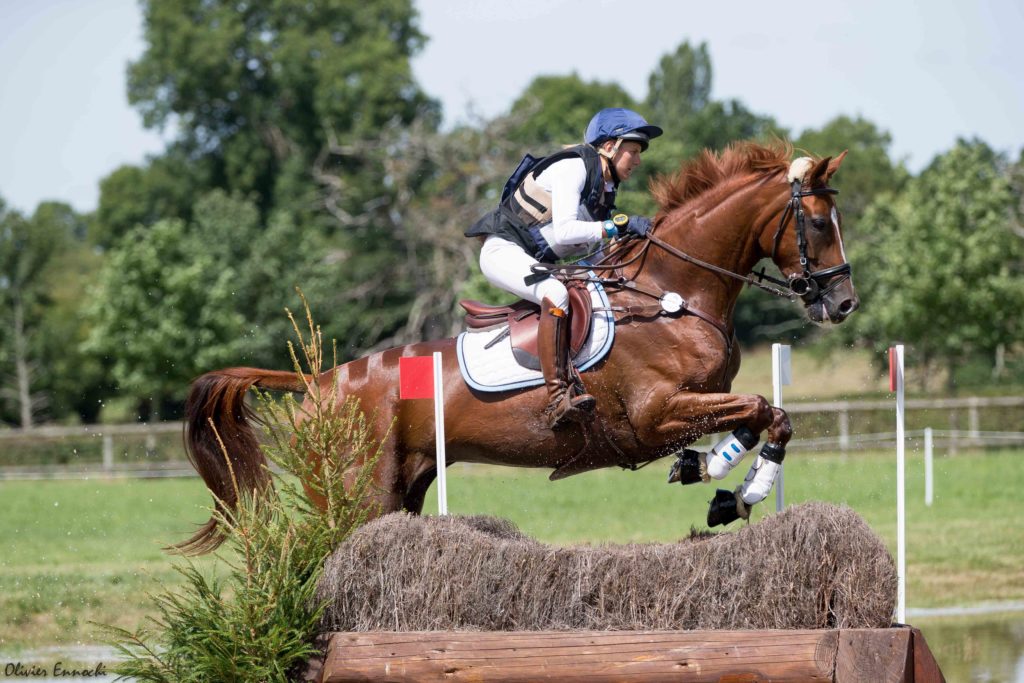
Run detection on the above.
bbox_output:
[310,627,945,683]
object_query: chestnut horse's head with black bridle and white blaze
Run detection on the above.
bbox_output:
[769,152,860,324]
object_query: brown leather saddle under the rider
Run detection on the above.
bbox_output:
[459,281,594,370]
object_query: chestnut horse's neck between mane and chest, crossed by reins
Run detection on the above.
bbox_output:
[650,183,779,323]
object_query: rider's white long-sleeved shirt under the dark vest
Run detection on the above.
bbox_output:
[537,158,615,258]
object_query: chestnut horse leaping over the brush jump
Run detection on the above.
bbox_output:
[178,142,858,552]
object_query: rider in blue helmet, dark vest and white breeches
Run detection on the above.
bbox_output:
[466,109,663,429]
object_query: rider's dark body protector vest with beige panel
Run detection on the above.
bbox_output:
[465,144,618,263]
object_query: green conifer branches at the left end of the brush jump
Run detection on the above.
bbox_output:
[106,308,380,683]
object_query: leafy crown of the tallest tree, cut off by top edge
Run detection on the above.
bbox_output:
[128,0,436,212]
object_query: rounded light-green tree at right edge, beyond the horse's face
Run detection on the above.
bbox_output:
[850,140,1024,390]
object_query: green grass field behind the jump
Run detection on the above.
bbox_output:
[0,452,1024,652]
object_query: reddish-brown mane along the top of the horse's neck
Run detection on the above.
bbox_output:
[650,141,793,214]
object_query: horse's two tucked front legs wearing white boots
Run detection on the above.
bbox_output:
[638,393,793,526]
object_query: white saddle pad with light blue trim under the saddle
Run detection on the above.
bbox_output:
[456,283,615,391]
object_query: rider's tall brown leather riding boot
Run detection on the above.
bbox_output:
[537,299,597,429]
